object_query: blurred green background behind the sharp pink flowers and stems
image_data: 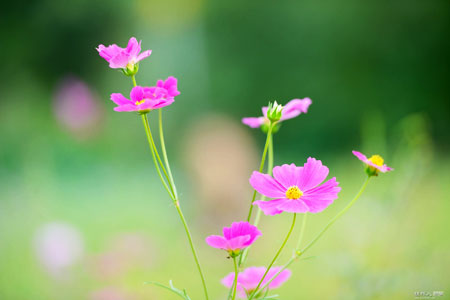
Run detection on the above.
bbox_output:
[0,0,450,300]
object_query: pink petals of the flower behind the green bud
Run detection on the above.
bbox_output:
[242,98,312,128]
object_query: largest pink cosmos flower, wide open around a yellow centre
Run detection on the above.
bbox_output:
[250,157,341,215]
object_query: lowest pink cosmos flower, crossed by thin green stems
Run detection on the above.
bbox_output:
[222,267,292,299]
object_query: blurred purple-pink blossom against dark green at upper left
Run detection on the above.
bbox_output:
[53,76,103,137]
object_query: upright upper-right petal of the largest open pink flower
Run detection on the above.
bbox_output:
[297,157,329,191]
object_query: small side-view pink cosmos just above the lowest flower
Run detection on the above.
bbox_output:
[206,222,262,254]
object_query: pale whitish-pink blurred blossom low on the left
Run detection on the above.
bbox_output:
[34,222,84,276]
